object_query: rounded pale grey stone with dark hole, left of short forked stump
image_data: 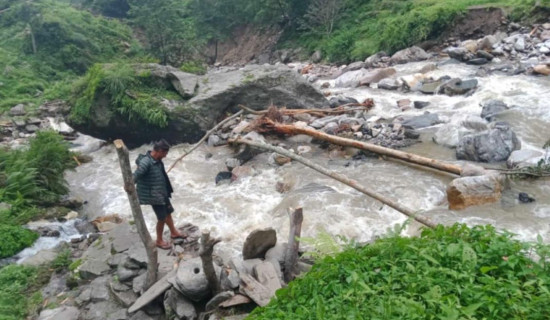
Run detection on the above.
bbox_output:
[174,257,220,301]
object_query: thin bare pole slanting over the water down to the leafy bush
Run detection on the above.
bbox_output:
[230,138,436,228]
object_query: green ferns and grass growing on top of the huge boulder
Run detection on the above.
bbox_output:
[70,64,175,127]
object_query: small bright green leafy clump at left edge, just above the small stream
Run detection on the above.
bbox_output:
[0,224,38,258]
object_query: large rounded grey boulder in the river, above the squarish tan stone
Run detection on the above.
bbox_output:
[456,122,521,162]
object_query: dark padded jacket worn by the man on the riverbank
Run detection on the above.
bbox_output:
[134,151,174,205]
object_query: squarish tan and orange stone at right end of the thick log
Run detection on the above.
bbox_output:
[447,173,503,210]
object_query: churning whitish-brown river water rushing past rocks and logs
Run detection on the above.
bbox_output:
[63,59,550,260]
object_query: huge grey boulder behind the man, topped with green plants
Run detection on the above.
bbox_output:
[68,64,328,147]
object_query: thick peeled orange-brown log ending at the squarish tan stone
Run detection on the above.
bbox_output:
[252,118,462,175]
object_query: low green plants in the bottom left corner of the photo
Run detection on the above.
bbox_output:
[0,265,49,320]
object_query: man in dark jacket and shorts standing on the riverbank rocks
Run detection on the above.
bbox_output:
[134,139,186,249]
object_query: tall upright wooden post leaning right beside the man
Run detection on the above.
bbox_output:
[114,139,158,289]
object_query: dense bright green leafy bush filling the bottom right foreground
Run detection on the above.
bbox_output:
[248,224,550,319]
